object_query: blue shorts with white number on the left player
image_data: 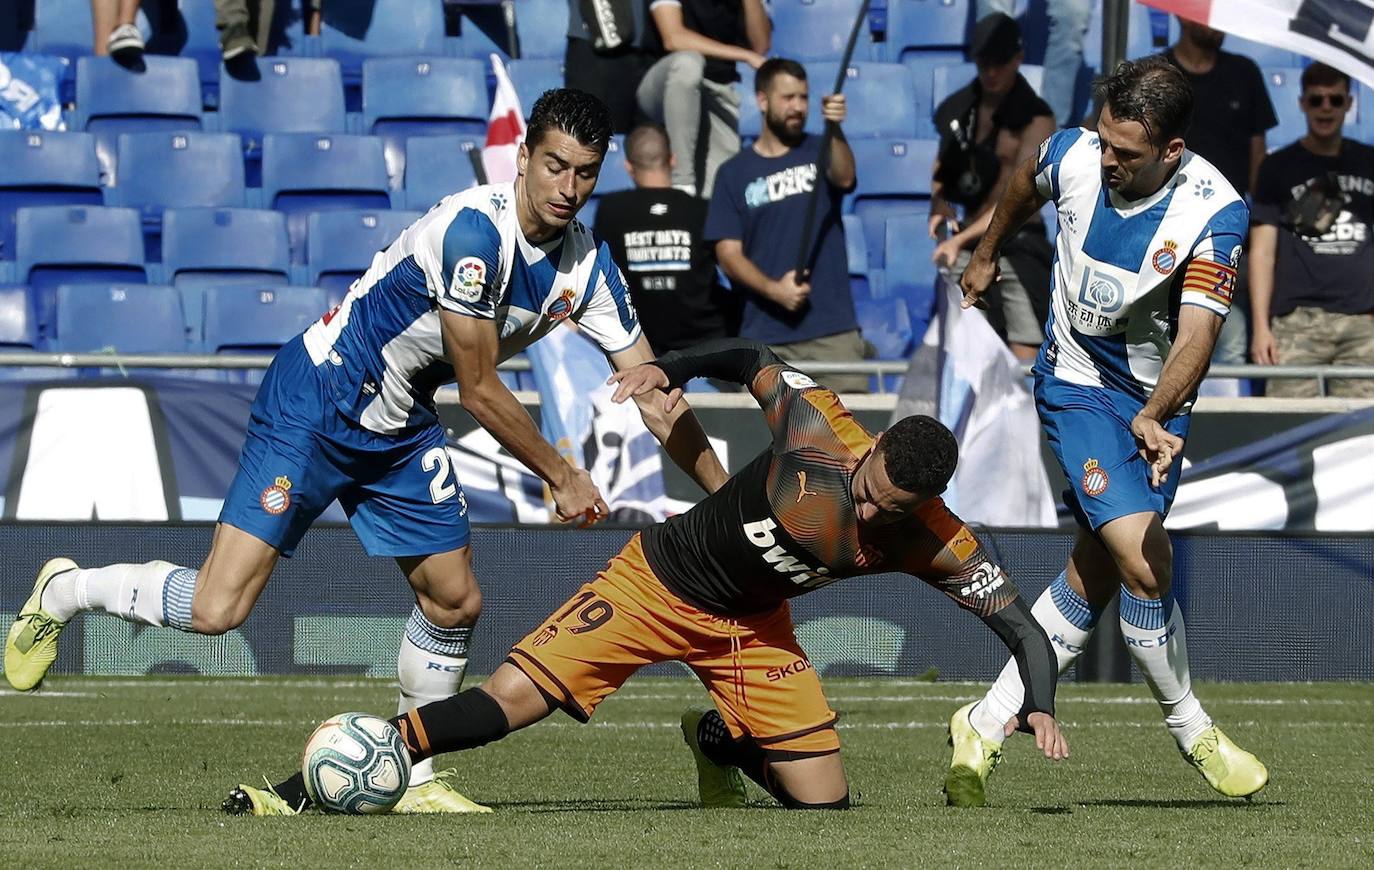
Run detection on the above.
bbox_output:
[220,337,469,557]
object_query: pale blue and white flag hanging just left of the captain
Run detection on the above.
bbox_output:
[892,276,1058,526]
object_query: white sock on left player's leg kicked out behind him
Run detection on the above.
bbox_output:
[43,561,196,631]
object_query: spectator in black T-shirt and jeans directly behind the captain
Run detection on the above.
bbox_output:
[1164,18,1278,364]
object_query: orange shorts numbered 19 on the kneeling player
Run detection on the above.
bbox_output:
[507,535,840,755]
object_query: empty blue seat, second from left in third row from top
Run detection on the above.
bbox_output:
[110,133,246,261]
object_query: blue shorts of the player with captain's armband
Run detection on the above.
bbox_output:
[1035,372,1191,532]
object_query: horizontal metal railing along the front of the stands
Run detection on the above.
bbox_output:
[0,350,1374,396]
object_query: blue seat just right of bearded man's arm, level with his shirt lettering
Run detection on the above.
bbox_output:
[845,139,938,266]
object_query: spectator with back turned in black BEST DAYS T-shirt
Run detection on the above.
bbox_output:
[596,124,732,356]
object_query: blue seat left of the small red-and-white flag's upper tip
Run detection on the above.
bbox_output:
[363,58,491,187]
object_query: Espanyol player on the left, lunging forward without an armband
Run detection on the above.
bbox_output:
[4,89,725,812]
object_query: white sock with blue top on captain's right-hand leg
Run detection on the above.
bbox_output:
[1121,587,1212,750]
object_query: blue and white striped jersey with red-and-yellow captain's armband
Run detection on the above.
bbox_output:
[1036,129,1249,401]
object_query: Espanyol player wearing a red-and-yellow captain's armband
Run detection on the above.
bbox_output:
[945,58,1268,805]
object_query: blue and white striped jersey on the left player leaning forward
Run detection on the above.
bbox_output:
[305,183,639,433]
